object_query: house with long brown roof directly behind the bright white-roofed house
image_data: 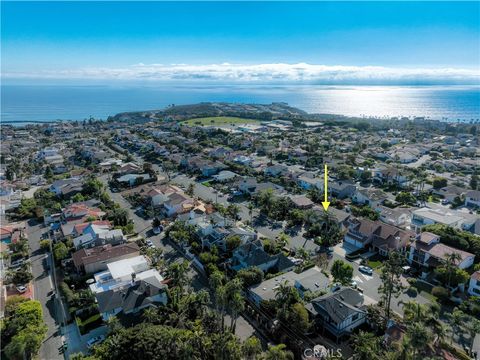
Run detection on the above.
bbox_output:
[72,243,140,274]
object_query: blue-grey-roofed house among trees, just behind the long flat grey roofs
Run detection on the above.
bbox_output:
[230,240,295,272]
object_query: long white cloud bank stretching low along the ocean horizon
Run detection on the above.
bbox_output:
[2,63,480,84]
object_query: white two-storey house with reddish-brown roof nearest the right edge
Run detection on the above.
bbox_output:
[408,232,475,273]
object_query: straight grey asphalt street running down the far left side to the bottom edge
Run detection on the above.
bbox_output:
[27,222,63,360]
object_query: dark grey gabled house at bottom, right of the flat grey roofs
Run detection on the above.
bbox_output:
[306,287,367,341]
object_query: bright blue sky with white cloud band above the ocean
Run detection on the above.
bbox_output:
[1,1,480,84]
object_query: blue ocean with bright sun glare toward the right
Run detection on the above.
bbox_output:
[1,84,480,123]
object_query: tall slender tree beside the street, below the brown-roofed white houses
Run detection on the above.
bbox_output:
[378,251,404,322]
